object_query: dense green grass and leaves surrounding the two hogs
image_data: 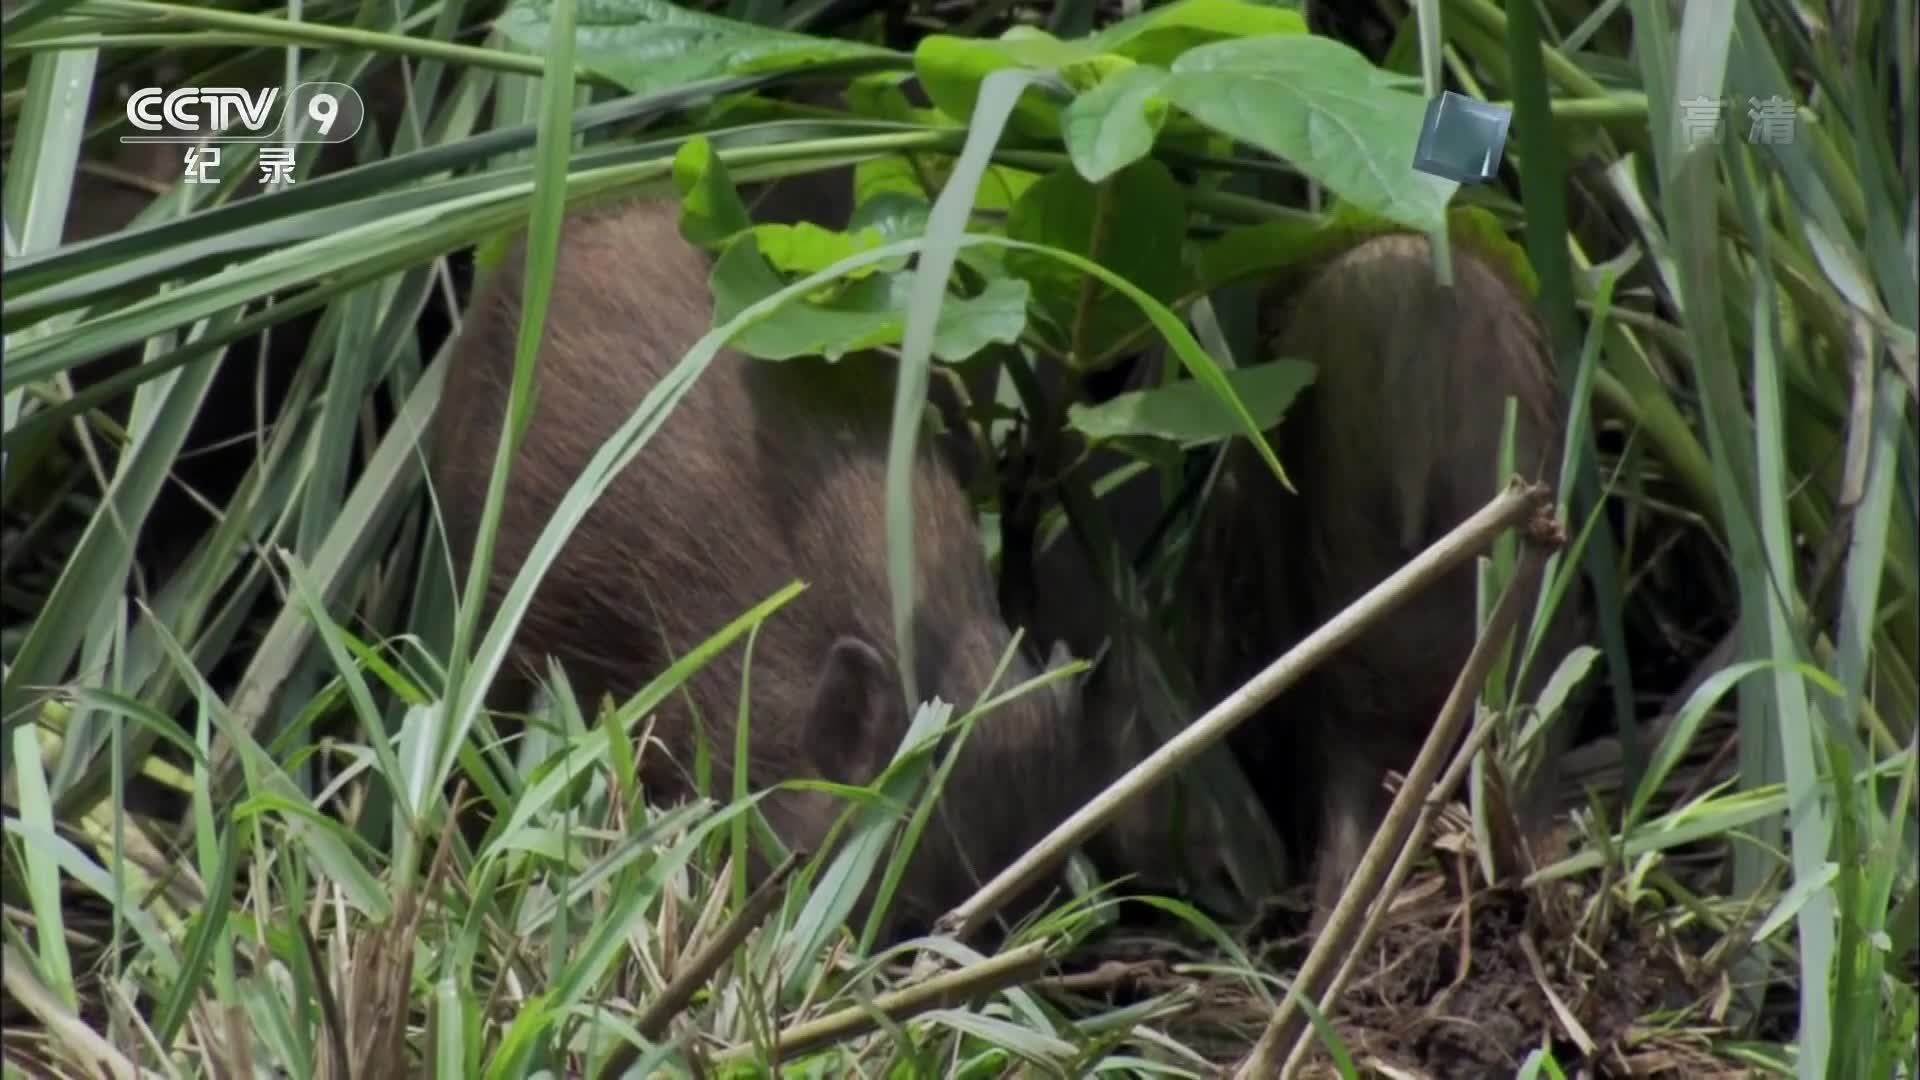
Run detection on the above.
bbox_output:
[0,0,1920,1080]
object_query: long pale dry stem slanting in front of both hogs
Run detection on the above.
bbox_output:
[937,479,1551,940]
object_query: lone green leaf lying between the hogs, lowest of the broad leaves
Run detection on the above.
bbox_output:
[1068,359,1313,448]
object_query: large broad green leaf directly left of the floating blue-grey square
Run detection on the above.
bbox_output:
[1162,35,1459,233]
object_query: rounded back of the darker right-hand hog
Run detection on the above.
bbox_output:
[1275,234,1563,765]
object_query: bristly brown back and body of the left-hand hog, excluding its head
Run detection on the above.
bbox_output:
[434,204,993,792]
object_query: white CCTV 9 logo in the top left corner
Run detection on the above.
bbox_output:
[121,83,367,142]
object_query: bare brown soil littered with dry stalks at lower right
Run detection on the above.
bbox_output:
[1068,711,1793,1080]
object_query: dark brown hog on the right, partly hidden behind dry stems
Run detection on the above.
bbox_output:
[1190,234,1584,917]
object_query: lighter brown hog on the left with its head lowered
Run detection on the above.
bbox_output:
[432,204,1198,930]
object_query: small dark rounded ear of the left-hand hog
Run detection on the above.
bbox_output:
[806,638,904,784]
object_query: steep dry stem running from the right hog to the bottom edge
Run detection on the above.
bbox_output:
[1238,507,1546,1080]
